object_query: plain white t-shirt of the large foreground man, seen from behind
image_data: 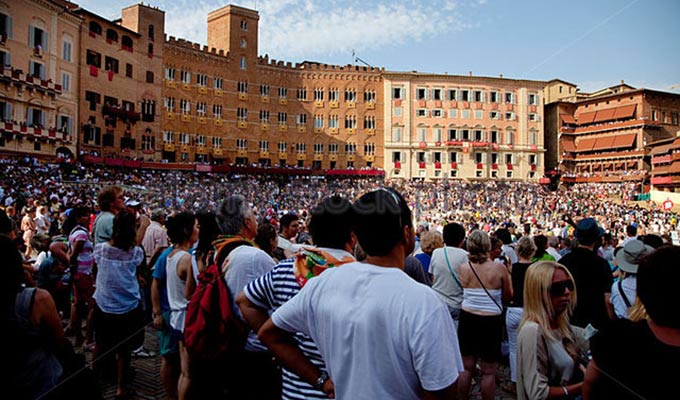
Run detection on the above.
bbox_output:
[272,262,463,399]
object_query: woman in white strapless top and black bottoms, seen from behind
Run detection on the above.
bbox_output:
[458,230,512,399]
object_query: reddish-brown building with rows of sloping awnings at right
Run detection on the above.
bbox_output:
[546,82,680,182]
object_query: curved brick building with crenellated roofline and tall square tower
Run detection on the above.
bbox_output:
[161,5,383,169]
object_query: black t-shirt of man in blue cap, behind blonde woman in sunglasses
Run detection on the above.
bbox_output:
[560,247,613,328]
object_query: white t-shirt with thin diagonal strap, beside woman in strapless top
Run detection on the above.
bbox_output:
[429,246,467,311]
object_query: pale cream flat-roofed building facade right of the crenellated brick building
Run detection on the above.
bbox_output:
[383,72,546,180]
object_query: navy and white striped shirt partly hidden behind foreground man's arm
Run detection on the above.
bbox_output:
[243,250,349,400]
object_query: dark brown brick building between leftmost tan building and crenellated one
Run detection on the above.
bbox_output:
[76,4,165,160]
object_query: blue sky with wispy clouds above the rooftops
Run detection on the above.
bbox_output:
[73,0,680,93]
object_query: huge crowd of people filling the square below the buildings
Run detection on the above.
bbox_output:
[0,155,680,399]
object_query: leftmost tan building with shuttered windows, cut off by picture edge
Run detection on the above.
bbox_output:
[0,0,81,158]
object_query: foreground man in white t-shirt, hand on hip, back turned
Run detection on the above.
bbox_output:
[258,189,463,400]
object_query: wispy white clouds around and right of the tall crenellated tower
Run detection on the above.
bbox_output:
[78,0,478,61]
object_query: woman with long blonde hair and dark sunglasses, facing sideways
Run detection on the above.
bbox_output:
[517,261,588,400]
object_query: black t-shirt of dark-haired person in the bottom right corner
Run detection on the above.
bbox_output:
[590,319,680,400]
